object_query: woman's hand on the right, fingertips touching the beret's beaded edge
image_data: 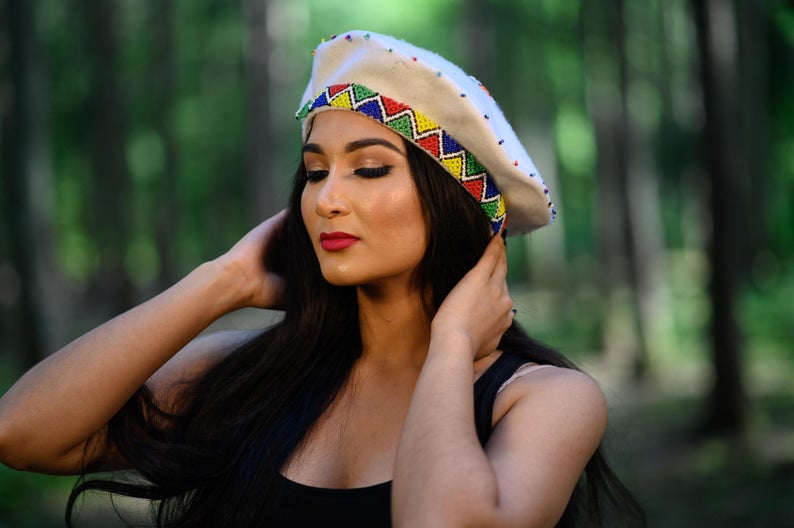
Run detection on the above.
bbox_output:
[432,235,514,359]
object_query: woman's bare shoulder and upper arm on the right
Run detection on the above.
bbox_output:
[486,367,607,526]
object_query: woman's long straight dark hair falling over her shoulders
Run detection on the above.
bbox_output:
[66,141,640,528]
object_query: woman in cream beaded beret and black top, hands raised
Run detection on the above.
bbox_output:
[0,32,639,527]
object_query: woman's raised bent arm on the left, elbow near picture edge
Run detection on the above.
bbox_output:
[0,212,285,474]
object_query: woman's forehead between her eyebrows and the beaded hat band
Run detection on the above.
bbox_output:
[306,110,405,152]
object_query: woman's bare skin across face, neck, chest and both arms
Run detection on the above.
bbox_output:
[0,111,606,527]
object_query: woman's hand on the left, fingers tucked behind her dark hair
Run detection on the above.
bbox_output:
[217,209,288,308]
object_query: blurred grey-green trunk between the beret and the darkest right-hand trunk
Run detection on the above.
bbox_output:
[581,0,647,377]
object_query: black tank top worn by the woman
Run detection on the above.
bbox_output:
[262,354,527,528]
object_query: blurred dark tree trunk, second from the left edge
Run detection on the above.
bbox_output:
[80,0,133,313]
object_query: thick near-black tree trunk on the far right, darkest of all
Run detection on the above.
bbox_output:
[692,0,753,432]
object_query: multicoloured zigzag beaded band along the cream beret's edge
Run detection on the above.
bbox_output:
[295,84,507,233]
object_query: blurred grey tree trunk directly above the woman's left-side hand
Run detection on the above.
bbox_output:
[243,0,279,223]
